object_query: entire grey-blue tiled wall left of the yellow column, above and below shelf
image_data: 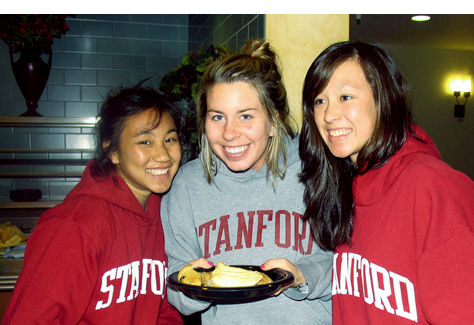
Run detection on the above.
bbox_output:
[0,15,264,201]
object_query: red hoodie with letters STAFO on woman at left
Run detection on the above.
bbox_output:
[2,163,182,324]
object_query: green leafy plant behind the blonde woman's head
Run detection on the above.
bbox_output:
[160,45,230,160]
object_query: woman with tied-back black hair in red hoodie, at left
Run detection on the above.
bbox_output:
[2,87,184,324]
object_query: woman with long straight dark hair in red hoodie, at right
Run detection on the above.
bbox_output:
[300,41,474,324]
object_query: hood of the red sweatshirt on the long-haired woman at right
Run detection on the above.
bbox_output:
[353,125,441,206]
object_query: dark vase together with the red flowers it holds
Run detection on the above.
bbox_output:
[0,15,69,116]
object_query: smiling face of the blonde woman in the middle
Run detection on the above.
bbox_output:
[205,82,273,172]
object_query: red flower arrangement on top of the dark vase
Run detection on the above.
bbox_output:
[0,15,69,52]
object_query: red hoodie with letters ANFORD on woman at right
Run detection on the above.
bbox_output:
[333,128,474,325]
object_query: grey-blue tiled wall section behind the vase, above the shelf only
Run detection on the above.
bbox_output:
[0,15,188,117]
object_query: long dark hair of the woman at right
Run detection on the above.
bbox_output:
[300,41,413,250]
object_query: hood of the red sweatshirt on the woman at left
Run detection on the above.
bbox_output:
[64,160,161,224]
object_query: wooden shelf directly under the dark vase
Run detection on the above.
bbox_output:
[0,116,97,127]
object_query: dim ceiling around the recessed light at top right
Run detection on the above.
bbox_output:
[350,14,474,51]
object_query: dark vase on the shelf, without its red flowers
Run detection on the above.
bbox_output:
[10,45,52,116]
